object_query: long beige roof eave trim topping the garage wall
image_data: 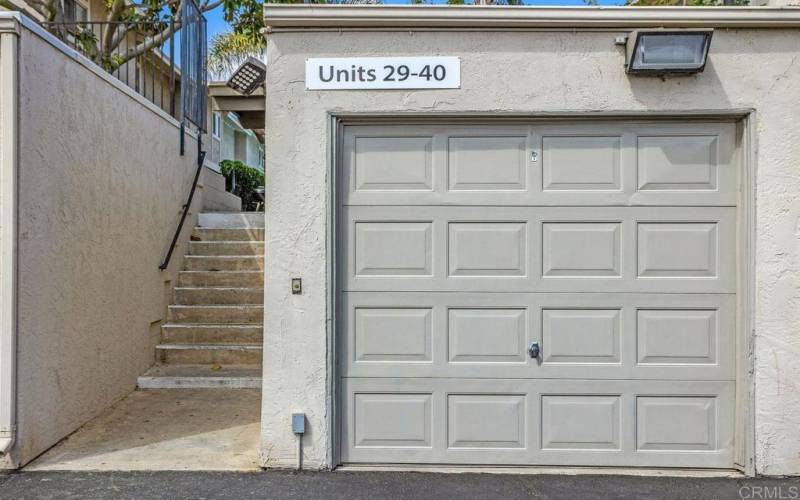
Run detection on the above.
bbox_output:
[264,4,800,31]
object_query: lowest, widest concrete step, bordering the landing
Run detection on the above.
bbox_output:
[138,365,261,389]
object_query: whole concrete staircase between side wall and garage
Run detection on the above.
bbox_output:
[139,212,264,389]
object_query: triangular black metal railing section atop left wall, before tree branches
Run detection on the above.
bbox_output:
[42,19,182,120]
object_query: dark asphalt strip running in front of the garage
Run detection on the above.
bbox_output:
[0,471,800,500]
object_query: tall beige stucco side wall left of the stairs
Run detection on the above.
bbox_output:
[3,22,202,466]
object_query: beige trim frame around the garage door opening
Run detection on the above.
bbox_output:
[327,109,757,476]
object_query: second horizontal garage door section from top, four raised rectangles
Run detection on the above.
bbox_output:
[342,206,736,293]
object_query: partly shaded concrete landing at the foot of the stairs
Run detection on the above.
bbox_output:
[27,389,261,471]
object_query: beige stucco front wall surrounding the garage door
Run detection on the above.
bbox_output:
[262,25,800,474]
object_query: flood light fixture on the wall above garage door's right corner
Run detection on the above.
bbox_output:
[626,29,714,75]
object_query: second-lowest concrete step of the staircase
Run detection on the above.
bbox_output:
[156,344,261,365]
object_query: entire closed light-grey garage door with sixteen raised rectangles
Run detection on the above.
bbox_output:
[337,121,739,467]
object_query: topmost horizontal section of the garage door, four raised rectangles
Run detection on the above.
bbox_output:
[341,122,738,206]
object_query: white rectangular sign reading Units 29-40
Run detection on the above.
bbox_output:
[306,57,461,90]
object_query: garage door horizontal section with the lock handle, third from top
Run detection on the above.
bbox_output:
[339,292,735,380]
